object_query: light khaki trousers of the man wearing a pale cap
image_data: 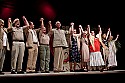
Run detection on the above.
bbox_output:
[11,42,25,71]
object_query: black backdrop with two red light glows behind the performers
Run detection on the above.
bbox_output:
[0,0,125,69]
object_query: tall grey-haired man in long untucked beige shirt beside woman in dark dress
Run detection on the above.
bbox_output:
[51,21,68,72]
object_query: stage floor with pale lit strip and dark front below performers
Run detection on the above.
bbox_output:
[0,70,125,83]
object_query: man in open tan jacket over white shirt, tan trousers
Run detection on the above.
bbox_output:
[26,21,39,73]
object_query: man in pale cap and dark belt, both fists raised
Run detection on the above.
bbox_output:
[8,16,29,74]
